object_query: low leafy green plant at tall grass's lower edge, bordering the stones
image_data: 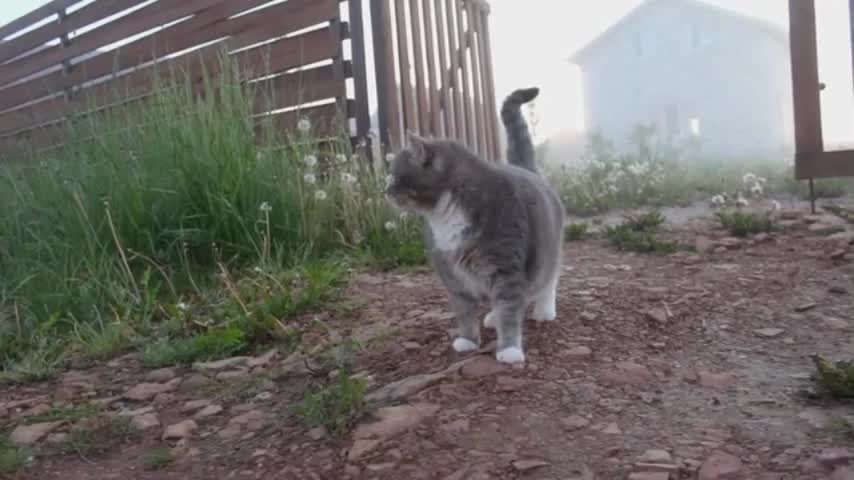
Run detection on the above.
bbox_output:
[142,327,247,368]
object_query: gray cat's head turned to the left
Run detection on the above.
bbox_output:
[385,132,464,214]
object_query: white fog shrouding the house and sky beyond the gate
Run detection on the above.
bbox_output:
[490,0,854,168]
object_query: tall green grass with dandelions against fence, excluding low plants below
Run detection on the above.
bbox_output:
[0,57,420,372]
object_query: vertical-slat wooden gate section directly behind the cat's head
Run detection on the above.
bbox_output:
[371,0,500,159]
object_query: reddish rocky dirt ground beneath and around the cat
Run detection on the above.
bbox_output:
[0,201,854,480]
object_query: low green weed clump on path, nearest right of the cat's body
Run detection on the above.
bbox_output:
[605,211,687,254]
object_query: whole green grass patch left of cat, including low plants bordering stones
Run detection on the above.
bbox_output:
[0,56,425,376]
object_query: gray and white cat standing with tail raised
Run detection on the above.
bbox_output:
[386,88,564,363]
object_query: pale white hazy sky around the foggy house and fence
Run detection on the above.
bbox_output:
[0,0,854,145]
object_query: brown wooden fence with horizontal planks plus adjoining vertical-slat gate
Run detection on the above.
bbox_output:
[0,0,498,158]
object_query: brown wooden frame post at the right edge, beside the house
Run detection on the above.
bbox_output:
[789,0,854,179]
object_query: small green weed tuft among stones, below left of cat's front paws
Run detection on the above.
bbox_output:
[292,371,368,437]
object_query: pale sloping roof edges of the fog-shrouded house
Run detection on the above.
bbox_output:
[569,0,789,64]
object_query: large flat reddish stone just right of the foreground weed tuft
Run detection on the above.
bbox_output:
[348,403,441,462]
